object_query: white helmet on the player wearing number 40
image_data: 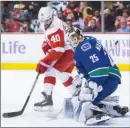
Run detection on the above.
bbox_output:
[38,7,54,25]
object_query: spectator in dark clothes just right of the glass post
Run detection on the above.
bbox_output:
[104,8,115,32]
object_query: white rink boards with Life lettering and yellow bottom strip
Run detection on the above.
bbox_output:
[1,33,130,71]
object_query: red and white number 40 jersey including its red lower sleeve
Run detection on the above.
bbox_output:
[40,17,73,66]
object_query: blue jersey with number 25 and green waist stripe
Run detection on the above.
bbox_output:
[74,36,121,85]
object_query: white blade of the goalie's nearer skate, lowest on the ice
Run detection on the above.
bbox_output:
[86,116,111,125]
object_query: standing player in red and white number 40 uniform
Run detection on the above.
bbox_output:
[34,7,79,109]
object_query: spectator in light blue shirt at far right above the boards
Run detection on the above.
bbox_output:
[117,18,130,32]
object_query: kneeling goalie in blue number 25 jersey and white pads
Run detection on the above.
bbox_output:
[64,28,129,124]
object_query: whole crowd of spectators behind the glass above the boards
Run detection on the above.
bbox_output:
[1,1,130,33]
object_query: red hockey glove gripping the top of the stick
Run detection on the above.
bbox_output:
[36,60,51,74]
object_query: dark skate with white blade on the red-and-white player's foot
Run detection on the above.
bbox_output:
[34,92,53,111]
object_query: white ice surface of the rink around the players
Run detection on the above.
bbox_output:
[1,71,130,127]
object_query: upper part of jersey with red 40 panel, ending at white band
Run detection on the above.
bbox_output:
[41,17,73,52]
